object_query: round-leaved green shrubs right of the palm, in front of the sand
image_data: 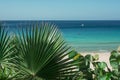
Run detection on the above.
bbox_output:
[69,51,120,80]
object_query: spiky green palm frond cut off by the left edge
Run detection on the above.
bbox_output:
[0,25,14,68]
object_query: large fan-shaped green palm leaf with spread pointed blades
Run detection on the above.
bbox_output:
[15,24,77,80]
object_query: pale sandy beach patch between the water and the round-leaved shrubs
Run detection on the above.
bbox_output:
[81,52,111,69]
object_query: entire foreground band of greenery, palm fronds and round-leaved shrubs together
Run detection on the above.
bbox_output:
[0,24,120,80]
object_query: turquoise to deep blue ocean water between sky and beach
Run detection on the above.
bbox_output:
[2,20,120,52]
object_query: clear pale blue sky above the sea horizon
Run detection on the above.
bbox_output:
[0,0,120,20]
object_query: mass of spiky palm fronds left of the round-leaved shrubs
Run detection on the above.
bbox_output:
[0,24,78,80]
